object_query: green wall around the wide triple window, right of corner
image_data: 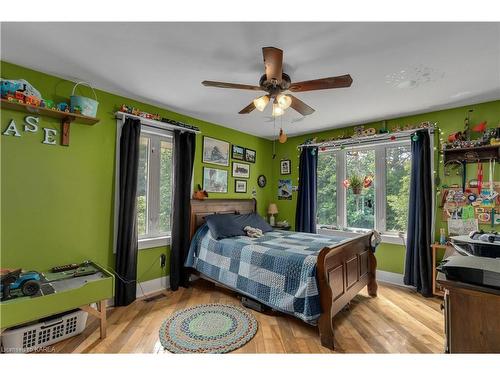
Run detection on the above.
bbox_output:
[272,101,500,273]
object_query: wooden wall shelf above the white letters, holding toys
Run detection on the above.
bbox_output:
[1,99,100,146]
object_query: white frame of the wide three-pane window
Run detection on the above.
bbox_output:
[317,139,411,245]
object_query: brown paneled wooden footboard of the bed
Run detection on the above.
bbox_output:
[318,232,377,349]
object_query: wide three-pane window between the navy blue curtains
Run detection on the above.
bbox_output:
[317,140,411,239]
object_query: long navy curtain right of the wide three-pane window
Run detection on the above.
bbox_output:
[404,130,434,297]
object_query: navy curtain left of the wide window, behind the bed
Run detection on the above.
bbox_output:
[295,147,318,233]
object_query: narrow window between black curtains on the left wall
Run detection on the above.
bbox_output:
[137,127,172,248]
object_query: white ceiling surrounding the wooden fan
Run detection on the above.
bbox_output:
[1,23,500,137]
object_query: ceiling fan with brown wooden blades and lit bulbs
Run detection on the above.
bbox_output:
[202,47,352,116]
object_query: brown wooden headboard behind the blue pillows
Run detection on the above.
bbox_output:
[189,199,257,239]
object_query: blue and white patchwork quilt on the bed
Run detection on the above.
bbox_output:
[185,224,349,325]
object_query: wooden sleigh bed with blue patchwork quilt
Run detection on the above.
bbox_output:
[186,199,377,349]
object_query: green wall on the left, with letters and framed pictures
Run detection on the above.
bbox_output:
[0,61,272,281]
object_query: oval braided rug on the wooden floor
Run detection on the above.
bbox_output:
[160,303,258,353]
